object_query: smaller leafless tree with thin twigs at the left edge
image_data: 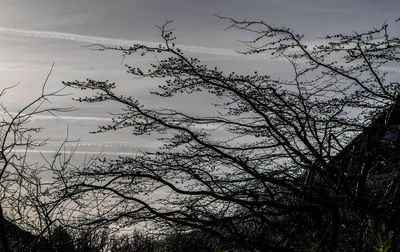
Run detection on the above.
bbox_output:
[0,67,78,251]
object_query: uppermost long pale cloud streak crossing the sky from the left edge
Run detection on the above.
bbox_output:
[0,27,241,56]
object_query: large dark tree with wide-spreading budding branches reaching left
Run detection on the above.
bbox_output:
[60,18,400,251]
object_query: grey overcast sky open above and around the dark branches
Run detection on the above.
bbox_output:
[0,0,400,156]
